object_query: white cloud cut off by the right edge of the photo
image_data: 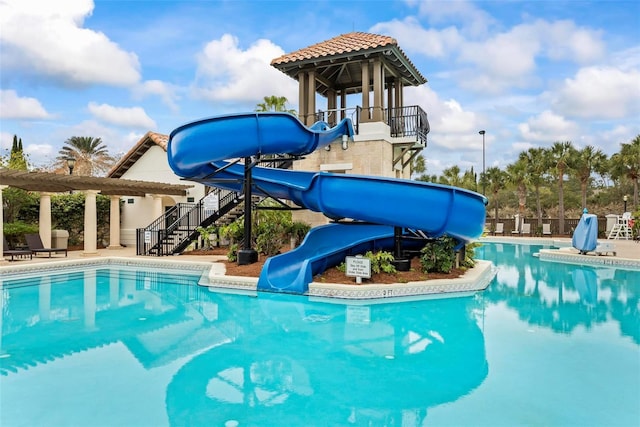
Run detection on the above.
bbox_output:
[550,67,640,119]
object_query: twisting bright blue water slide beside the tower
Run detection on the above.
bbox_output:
[167,112,487,293]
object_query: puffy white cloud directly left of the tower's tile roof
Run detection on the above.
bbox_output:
[193,34,298,103]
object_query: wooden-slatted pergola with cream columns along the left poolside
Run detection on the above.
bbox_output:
[0,168,193,256]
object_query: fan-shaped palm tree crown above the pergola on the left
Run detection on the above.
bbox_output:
[56,136,115,176]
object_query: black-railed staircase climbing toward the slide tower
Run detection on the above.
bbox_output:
[136,155,292,256]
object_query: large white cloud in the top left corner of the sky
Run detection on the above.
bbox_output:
[0,0,140,86]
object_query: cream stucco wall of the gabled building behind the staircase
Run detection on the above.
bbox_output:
[120,146,205,246]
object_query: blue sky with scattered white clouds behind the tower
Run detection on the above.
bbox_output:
[0,0,640,174]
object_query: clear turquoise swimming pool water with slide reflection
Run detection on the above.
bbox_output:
[0,244,640,427]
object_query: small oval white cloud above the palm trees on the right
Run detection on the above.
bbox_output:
[518,110,580,145]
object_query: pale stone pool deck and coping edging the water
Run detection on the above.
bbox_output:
[0,236,640,302]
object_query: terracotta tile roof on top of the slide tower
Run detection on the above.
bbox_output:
[271,32,398,65]
